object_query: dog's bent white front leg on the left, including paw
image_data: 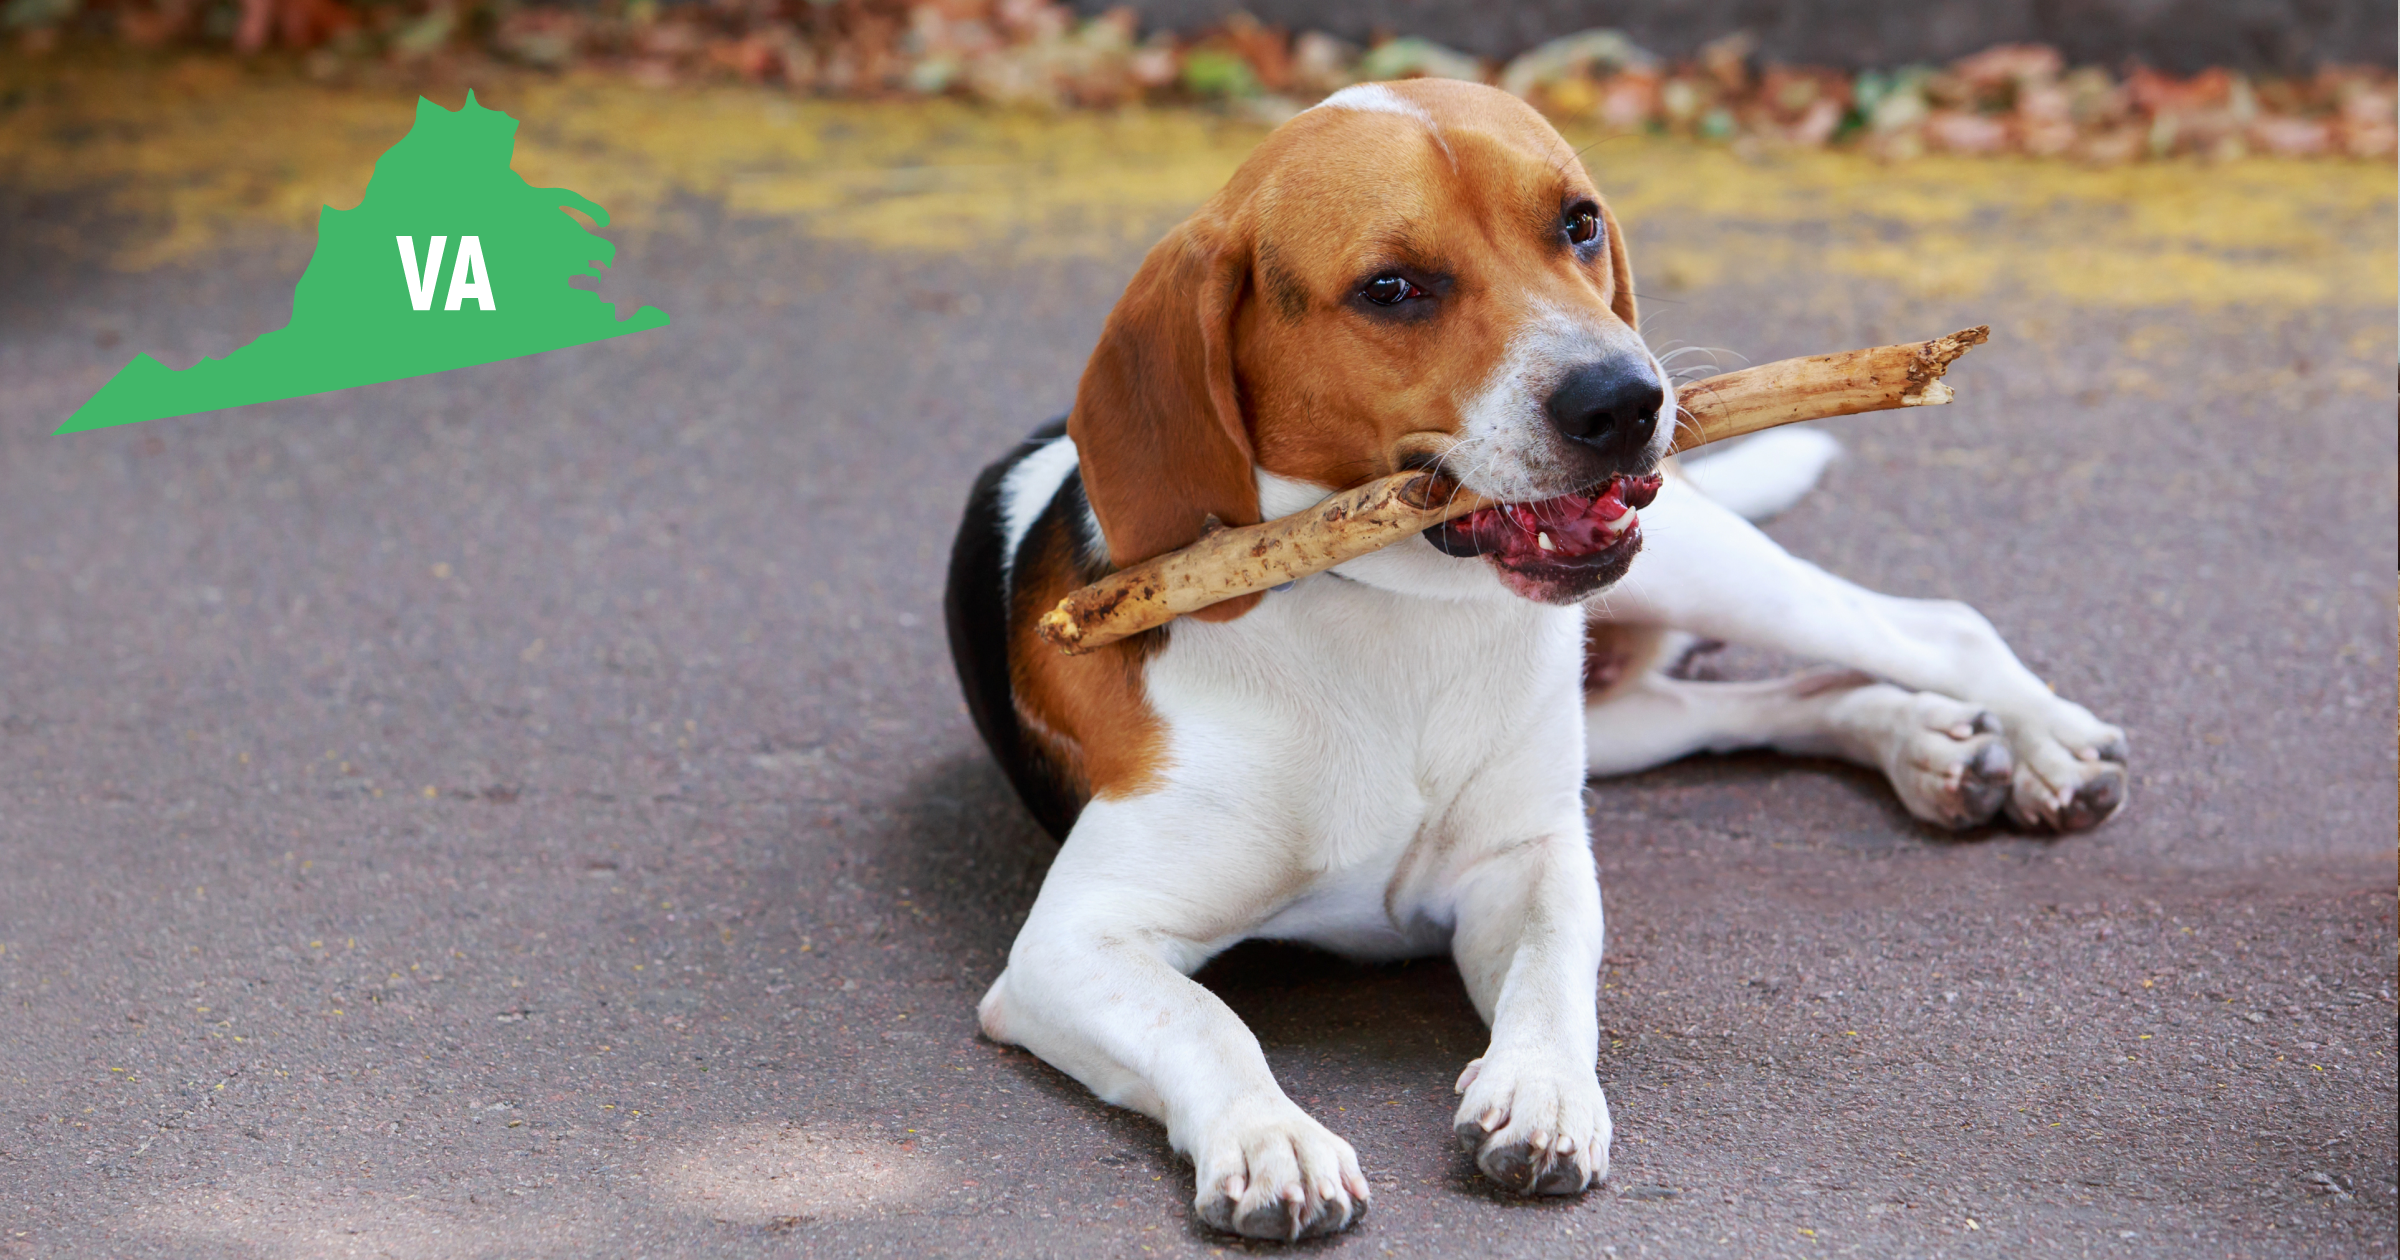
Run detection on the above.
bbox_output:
[979,802,1368,1241]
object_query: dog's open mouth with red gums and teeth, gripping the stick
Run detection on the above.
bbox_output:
[1426,473,1658,602]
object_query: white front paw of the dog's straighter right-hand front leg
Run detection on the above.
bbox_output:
[1452,1056,1610,1195]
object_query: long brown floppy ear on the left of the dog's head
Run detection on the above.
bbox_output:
[1066,206,1258,622]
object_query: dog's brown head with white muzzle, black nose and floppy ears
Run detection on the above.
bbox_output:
[1068,79,1673,609]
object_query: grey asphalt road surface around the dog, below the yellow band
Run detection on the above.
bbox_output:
[0,112,2400,1260]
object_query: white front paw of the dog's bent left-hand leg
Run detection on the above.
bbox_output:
[1193,1097,1370,1243]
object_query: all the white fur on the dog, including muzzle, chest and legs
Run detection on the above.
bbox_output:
[979,286,2122,1238]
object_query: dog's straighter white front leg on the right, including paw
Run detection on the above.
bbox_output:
[1450,830,1610,1195]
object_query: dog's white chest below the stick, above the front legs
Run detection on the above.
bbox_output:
[1147,576,1584,958]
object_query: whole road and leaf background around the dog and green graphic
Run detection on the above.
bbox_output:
[0,0,2400,1258]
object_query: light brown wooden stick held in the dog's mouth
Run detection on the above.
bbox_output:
[1034,326,1992,655]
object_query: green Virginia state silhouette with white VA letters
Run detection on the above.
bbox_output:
[58,91,667,434]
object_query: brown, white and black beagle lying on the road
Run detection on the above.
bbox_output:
[948,79,2126,1238]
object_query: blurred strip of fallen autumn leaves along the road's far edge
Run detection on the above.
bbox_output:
[0,0,2395,151]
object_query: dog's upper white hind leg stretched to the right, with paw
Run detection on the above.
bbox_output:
[1594,478,2126,830]
